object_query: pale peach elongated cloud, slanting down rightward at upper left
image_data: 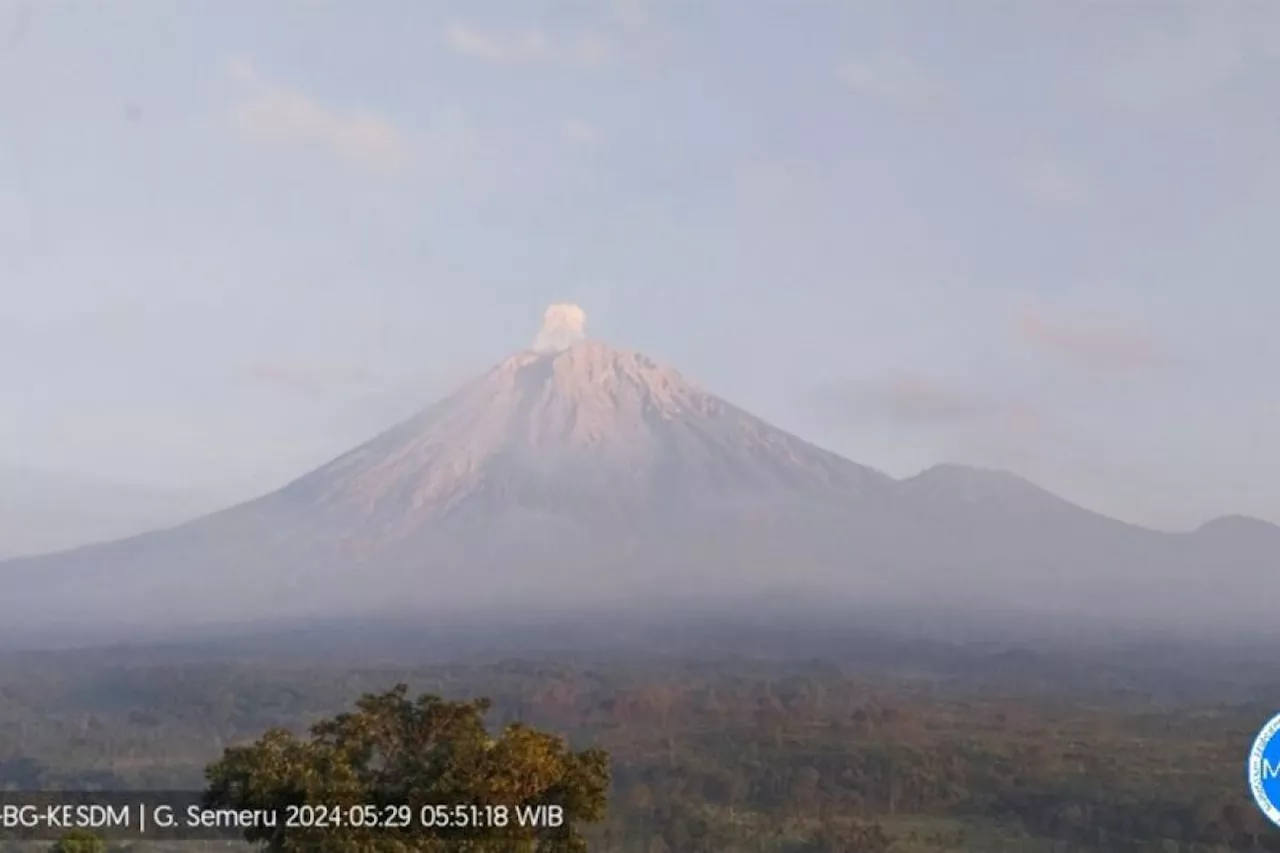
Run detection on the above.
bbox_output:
[227,58,410,170]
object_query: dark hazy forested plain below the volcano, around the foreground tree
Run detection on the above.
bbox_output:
[0,617,1280,853]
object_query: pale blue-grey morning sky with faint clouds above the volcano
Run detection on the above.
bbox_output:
[0,0,1280,529]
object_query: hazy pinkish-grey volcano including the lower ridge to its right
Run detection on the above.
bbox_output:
[0,308,1280,628]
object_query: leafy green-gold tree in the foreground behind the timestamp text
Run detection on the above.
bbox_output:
[205,684,609,853]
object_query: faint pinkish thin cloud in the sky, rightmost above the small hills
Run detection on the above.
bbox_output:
[1015,311,1171,377]
